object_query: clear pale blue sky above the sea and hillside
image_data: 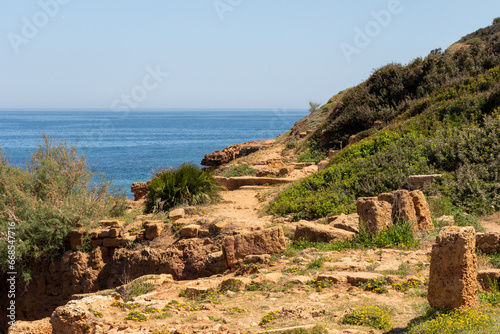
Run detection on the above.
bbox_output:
[0,0,500,109]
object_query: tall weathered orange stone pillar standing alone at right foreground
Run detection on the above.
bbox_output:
[427,226,478,309]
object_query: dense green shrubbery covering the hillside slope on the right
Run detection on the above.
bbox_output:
[268,20,500,219]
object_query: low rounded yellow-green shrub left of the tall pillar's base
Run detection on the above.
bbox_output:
[340,306,392,331]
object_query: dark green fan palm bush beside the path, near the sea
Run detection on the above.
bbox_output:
[145,163,218,213]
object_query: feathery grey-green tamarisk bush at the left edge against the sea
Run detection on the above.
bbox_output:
[0,135,125,281]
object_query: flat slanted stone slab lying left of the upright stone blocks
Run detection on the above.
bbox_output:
[294,221,355,242]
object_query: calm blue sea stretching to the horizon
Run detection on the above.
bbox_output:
[0,109,308,197]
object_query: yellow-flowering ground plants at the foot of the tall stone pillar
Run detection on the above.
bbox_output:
[406,308,494,334]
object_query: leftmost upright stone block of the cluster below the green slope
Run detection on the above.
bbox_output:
[356,197,392,234]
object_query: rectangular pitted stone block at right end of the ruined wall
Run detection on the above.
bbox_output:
[222,226,286,268]
